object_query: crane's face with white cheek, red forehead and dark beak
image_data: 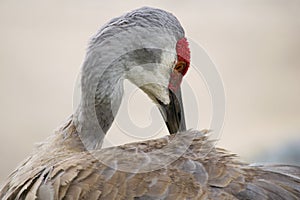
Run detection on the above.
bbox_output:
[127,37,190,134]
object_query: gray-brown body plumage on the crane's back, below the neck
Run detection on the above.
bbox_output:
[1,119,300,200]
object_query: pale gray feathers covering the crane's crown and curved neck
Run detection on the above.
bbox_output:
[74,7,184,149]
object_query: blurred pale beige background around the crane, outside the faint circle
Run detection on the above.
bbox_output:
[0,0,300,183]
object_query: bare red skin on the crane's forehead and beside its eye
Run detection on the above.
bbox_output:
[169,37,191,92]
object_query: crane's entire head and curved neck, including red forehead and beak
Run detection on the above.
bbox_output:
[77,7,190,137]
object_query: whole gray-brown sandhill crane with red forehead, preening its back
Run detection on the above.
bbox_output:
[0,7,300,200]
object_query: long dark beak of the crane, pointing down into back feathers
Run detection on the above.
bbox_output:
[158,88,186,134]
